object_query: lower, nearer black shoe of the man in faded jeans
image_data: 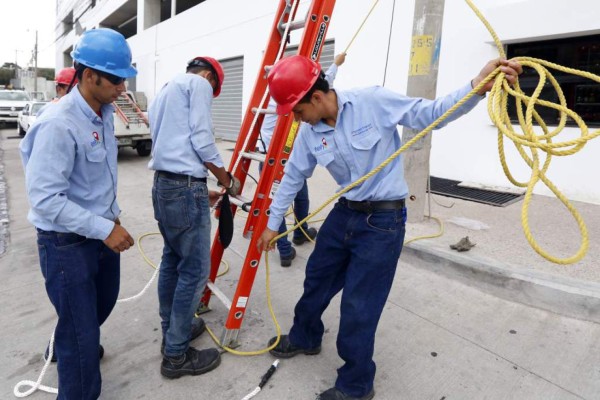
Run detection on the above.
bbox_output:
[160,347,221,379]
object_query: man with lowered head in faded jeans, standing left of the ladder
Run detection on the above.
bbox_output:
[148,57,240,379]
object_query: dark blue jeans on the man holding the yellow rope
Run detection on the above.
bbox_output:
[289,203,406,397]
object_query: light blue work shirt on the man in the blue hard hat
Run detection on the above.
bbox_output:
[19,86,121,240]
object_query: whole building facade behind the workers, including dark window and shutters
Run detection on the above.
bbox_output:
[56,0,600,204]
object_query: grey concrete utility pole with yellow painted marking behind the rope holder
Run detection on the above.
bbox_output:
[402,0,444,222]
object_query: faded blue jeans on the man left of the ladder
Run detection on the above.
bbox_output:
[152,175,210,357]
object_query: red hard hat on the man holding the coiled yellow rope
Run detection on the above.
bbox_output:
[267,55,321,115]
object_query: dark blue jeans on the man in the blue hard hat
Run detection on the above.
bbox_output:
[37,229,121,400]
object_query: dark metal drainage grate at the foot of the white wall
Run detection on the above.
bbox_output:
[430,176,523,207]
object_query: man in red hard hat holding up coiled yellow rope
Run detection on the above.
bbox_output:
[257,56,522,400]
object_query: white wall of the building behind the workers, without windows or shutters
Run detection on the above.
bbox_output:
[52,0,600,204]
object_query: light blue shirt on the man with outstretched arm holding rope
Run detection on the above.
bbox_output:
[267,84,484,231]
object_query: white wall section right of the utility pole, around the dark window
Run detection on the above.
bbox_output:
[431,0,600,204]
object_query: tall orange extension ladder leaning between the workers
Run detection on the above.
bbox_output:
[198,0,335,347]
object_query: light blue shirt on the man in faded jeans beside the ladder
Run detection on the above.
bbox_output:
[148,74,223,178]
